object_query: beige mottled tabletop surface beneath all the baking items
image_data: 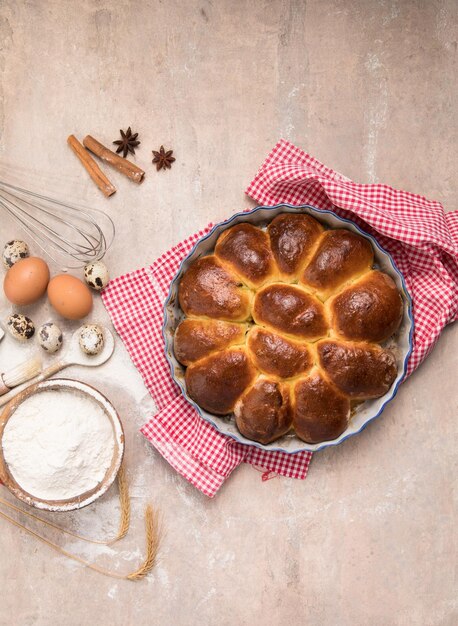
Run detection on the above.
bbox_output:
[0,0,458,626]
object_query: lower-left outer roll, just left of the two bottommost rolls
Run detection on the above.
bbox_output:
[185,348,256,415]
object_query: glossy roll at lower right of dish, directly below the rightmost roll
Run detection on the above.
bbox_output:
[317,340,397,400]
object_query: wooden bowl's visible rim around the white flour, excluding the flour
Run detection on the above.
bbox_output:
[0,378,124,512]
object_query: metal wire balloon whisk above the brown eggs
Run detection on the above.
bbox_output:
[0,181,115,269]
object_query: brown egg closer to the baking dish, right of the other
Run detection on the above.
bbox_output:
[47,274,92,320]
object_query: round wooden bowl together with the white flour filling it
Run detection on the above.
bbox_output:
[0,379,124,511]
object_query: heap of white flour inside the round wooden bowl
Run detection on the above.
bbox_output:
[2,390,114,500]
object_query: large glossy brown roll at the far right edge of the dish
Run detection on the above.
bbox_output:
[330,270,403,342]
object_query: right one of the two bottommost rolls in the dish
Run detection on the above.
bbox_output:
[293,370,350,443]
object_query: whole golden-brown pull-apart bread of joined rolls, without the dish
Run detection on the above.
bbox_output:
[174,213,404,445]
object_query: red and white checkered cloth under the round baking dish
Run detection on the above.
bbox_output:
[102,140,458,497]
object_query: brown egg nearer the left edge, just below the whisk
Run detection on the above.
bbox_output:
[3,256,49,306]
